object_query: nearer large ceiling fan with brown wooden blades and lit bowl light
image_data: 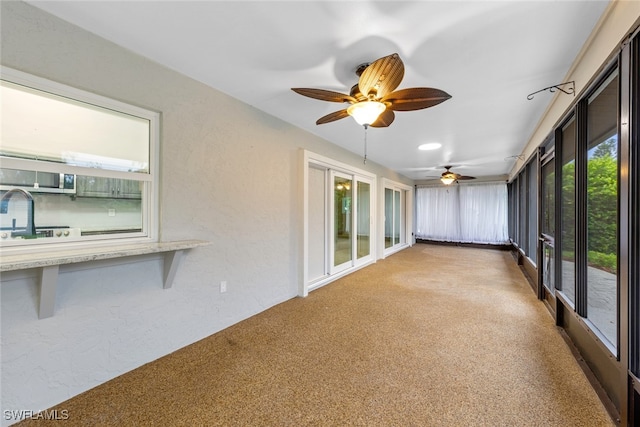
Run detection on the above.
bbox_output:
[291,53,451,128]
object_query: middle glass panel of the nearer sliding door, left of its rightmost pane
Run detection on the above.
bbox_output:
[331,172,353,272]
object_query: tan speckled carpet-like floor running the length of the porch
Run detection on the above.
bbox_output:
[22,244,614,427]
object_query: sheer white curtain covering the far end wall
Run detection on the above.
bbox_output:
[416,182,509,244]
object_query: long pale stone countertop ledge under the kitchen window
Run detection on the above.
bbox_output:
[0,240,211,272]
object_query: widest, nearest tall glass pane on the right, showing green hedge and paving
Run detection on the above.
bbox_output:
[587,72,619,347]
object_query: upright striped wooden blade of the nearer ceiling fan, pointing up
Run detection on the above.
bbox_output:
[358,53,404,98]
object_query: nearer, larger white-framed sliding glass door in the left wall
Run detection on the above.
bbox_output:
[299,151,378,296]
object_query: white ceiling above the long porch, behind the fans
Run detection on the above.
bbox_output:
[28,0,608,180]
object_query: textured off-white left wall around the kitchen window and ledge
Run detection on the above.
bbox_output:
[0,1,411,424]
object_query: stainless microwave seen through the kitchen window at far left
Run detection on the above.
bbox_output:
[0,168,76,194]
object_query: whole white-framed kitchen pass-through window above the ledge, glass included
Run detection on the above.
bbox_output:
[0,68,158,251]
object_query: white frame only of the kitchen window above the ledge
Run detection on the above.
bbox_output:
[0,66,160,255]
